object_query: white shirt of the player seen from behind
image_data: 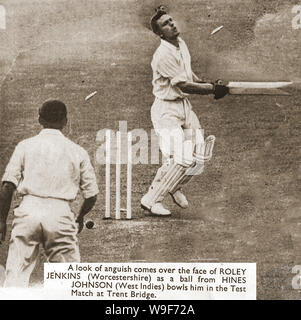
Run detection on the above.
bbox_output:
[2,129,98,201]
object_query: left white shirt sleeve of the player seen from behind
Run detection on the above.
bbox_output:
[2,143,25,188]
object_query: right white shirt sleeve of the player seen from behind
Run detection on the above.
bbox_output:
[80,150,99,199]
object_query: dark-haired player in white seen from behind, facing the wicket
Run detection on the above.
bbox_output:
[0,100,98,287]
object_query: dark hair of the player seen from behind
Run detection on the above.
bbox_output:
[39,100,67,123]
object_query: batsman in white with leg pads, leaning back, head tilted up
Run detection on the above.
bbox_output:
[141,6,229,216]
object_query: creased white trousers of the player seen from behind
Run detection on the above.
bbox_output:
[4,195,80,287]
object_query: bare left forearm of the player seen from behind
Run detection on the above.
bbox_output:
[0,181,16,244]
